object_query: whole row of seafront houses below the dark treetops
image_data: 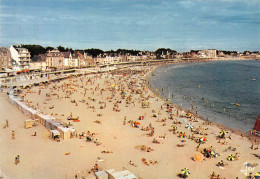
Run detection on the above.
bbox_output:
[0,45,260,71]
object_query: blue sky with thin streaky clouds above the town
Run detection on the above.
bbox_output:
[0,0,260,52]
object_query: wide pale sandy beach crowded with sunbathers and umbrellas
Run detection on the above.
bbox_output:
[0,66,260,179]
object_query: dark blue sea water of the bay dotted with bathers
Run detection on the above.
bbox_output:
[149,60,260,132]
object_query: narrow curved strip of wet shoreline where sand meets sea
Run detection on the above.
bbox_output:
[146,60,260,142]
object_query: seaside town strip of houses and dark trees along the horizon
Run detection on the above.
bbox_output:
[0,45,260,73]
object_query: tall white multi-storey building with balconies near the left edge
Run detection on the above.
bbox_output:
[10,45,31,69]
